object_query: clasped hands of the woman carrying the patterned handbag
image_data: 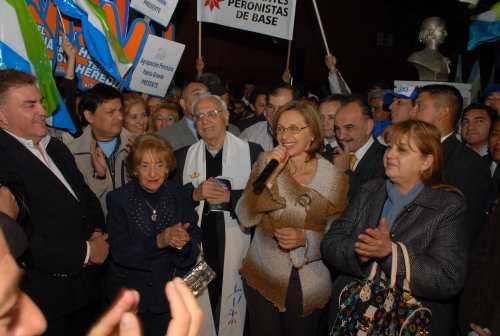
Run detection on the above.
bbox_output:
[354,218,392,262]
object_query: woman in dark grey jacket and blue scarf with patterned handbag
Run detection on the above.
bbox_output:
[321,121,467,336]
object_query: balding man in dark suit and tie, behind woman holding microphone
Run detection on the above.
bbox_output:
[335,96,385,201]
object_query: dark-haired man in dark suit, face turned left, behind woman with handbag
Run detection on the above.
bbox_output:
[415,84,491,243]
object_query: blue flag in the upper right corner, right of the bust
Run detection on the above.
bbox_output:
[467,2,500,50]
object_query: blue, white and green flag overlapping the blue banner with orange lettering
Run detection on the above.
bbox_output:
[54,0,132,85]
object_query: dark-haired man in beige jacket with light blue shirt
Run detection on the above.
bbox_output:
[68,84,133,214]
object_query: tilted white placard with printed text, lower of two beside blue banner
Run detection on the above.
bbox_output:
[130,34,185,97]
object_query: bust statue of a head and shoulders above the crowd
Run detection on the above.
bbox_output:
[408,17,450,81]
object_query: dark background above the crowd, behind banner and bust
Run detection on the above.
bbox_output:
[169,0,492,92]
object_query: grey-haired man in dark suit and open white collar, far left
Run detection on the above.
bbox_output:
[0,70,108,335]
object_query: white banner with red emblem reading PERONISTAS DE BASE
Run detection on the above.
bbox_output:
[197,0,296,40]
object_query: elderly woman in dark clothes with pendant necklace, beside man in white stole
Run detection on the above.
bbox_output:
[107,135,201,336]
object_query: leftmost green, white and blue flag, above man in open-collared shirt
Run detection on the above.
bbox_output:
[0,0,76,133]
